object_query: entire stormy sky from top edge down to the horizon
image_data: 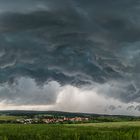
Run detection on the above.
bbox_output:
[0,0,140,115]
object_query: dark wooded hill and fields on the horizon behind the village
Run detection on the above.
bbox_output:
[0,110,140,123]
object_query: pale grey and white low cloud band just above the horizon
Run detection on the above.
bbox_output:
[0,77,139,115]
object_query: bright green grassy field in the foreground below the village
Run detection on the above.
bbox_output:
[0,122,140,140]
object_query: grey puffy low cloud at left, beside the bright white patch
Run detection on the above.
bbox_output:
[0,78,61,105]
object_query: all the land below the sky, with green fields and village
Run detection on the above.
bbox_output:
[0,111,140,140]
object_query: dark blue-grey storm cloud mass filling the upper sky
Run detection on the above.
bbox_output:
[0,0,140,105]
